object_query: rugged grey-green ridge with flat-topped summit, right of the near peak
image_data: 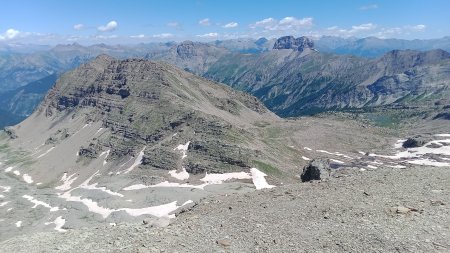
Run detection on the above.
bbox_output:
[204,37,450,116]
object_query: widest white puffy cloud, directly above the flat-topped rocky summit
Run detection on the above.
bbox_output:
[250,17,313,31]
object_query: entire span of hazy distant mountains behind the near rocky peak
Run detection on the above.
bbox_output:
[0,36,450,126]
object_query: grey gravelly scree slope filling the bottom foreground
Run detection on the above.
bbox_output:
[0,166,450,252]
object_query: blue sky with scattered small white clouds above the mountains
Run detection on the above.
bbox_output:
[0,0,450,44]
